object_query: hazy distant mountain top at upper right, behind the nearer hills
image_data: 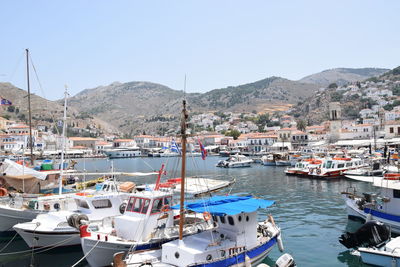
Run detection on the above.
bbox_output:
[299,68,389,87]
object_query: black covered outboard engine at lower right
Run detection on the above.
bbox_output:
[339,220,390,248]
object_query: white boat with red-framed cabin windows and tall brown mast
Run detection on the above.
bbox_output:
[81,100,216,266]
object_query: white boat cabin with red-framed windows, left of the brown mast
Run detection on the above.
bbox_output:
[114,191,174,241]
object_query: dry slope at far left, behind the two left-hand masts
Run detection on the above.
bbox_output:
[0,83,115,136]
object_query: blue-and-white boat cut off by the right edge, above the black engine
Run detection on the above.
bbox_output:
[342,176,400,234]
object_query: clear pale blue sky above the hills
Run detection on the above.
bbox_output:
[0,0,400,99]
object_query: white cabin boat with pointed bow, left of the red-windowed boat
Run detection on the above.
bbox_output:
[13,181,128,248]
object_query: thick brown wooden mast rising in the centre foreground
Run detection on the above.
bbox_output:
[179,99,188,240]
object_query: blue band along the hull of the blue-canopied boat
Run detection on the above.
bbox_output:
[195,237,276,267]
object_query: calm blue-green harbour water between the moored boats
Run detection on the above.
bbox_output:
[0,157,374,267]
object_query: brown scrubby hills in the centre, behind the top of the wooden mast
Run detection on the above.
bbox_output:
[66,77,318,134]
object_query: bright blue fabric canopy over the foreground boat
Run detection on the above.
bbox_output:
[172,196,275,216]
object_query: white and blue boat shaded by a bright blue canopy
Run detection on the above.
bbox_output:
[120,195,283,267]
